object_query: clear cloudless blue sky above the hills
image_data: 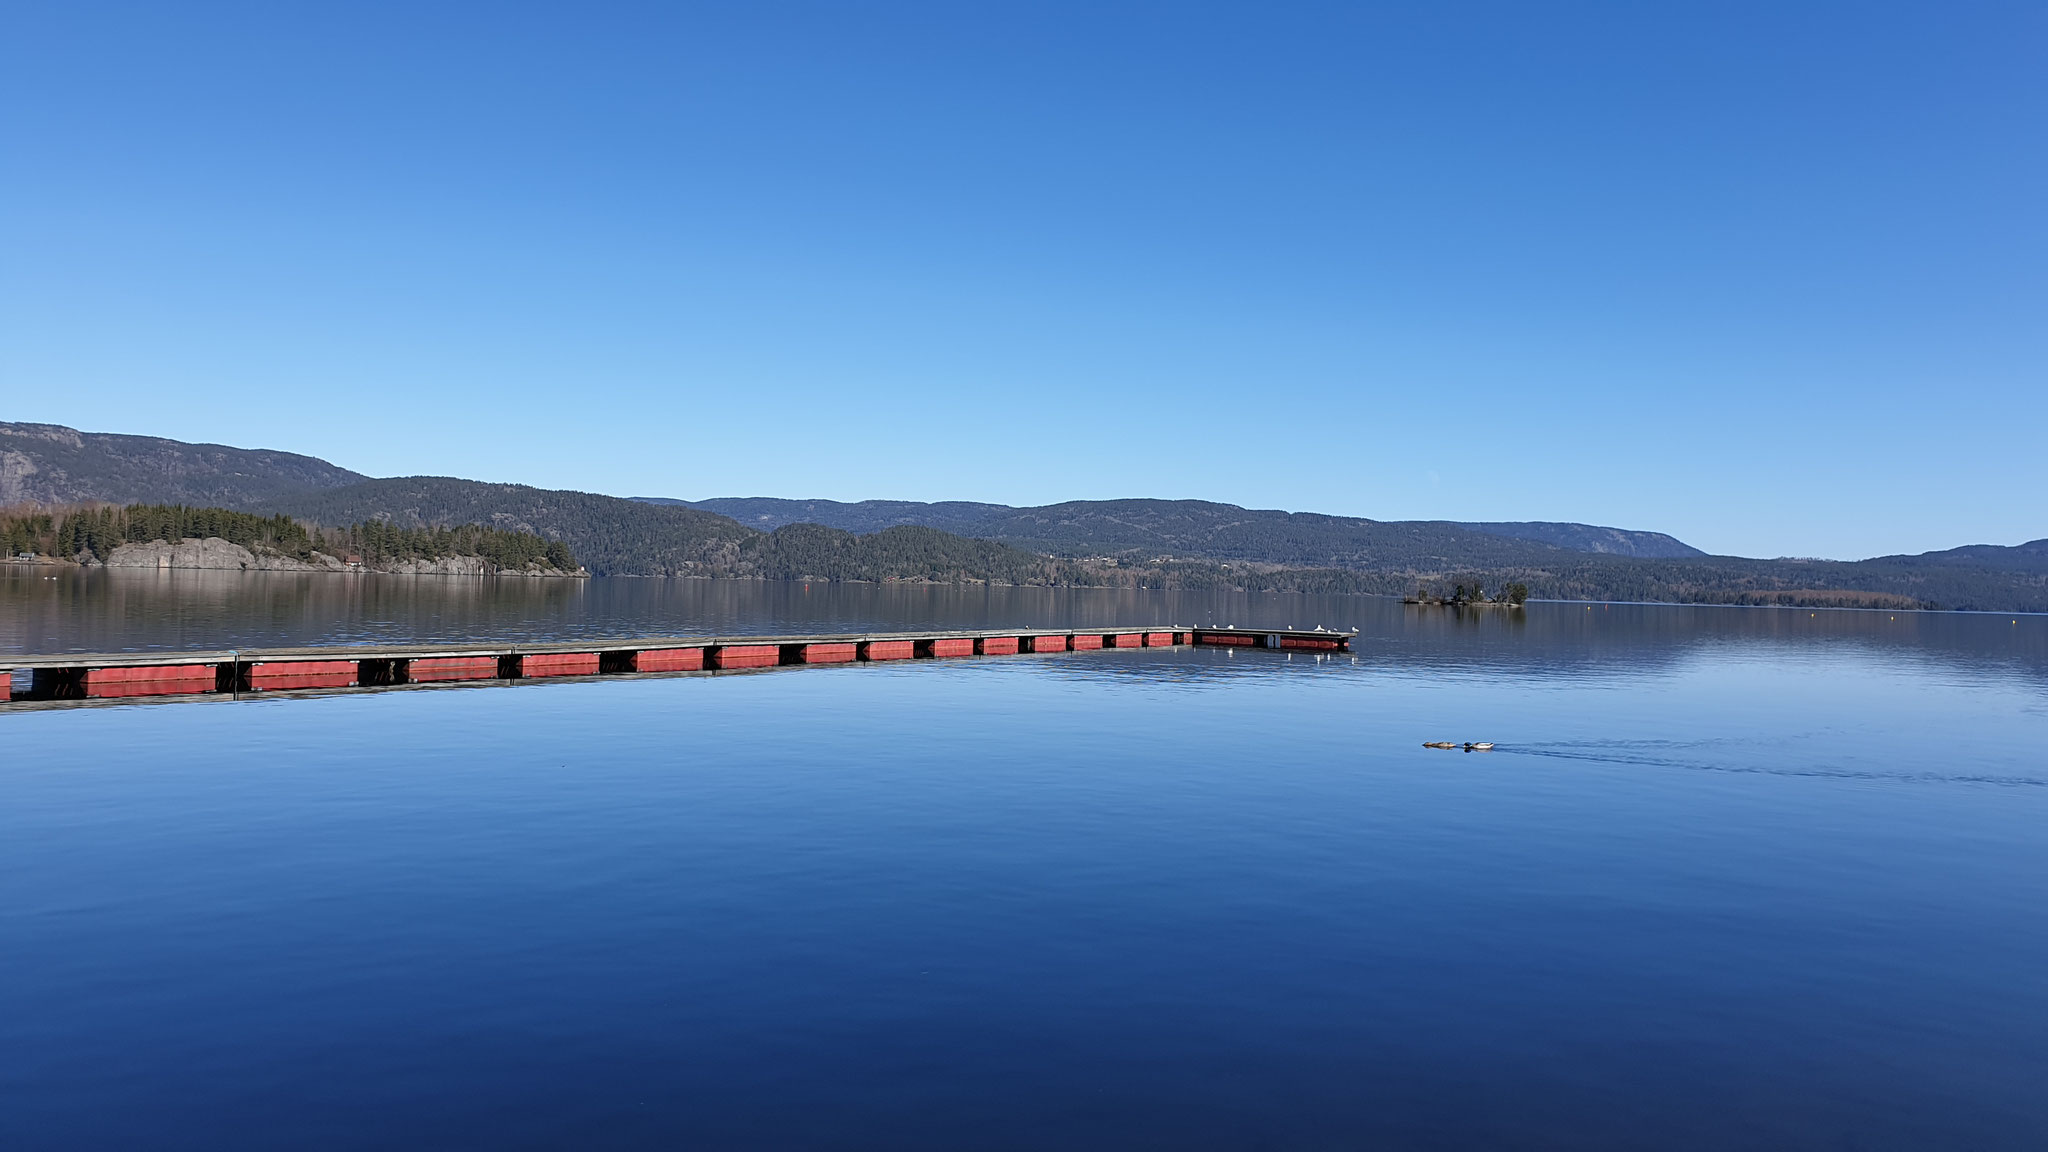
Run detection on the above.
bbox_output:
[0,0,2048,556]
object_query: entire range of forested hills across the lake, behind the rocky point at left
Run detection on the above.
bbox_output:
[0,424,2048,611]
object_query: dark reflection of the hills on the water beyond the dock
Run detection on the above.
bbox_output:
[0,568,2048,687]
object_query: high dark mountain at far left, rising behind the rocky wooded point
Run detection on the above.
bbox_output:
[0,422,369,508]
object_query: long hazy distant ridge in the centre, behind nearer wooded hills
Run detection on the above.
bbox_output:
[659,496,1706,568]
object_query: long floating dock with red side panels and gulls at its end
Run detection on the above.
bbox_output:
[0,627,1358,703]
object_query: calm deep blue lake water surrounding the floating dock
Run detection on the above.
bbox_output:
[0,570,2048,1150]
